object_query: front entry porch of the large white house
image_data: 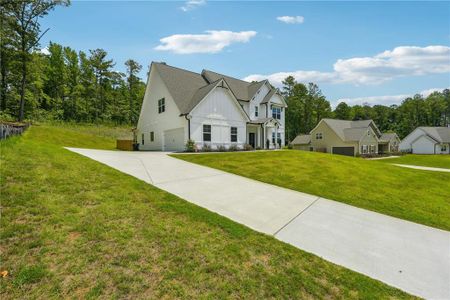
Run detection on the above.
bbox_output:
[247,118,284,149]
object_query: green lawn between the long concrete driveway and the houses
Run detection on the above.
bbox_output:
[173,150,450,230]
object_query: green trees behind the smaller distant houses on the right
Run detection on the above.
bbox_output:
[281,76,450,141]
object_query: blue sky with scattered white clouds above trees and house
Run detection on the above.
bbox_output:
[41,0,450,104]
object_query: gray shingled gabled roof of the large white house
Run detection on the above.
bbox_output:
[152,62,284,115]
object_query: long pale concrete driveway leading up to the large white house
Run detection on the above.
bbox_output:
[67,148,450,299]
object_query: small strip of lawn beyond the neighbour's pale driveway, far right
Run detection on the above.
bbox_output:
[377,154,450,169]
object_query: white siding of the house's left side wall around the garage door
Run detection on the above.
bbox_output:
[137,68,187,150]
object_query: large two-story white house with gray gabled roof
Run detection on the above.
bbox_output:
[136,62,287,151]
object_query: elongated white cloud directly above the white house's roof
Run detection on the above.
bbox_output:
[155,30,256,54]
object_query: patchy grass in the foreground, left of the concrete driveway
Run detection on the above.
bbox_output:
[0,126,411,299]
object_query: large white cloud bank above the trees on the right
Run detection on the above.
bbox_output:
[246,46,450,86]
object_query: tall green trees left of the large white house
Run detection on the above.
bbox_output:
[0,0,145,124]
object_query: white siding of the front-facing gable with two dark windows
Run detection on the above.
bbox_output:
[191,86,246,148]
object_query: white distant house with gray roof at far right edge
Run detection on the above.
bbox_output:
[400,127,450,154]
